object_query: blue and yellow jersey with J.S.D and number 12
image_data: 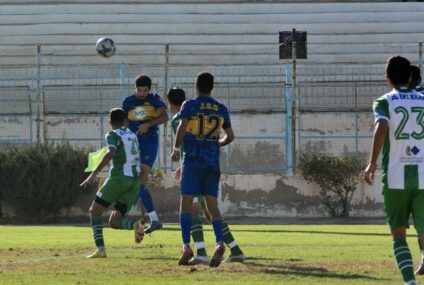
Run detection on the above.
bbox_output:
[180,96,231,167]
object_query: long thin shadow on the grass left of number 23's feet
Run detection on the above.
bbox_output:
[244,258,388,281]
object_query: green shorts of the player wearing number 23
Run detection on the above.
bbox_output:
[383,189,424,233]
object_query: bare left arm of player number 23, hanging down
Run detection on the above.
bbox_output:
[364,120,389,185]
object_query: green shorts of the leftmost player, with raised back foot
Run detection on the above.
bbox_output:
[96,176,140,215]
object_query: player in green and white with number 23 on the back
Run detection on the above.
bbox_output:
[364,56,424,285]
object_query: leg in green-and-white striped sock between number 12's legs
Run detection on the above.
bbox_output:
[188,196,209,265]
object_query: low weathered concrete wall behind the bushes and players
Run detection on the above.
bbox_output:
[2,172,383,221]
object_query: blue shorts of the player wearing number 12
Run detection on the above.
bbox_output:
[180,163,221,197]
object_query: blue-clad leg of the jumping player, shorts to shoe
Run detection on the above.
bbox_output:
[139,134,162,233]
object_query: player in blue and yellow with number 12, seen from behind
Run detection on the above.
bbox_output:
[171,72,234,267]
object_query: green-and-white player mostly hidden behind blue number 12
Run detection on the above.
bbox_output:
[167,87,245,265]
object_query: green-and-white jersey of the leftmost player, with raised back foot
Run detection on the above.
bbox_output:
[106,128,140,177]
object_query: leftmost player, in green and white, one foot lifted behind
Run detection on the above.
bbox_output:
[81,108,144,258]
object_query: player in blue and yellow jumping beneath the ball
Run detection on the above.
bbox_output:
[122,74,168,233]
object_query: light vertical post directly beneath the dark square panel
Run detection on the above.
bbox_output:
[285,62,293,175]
